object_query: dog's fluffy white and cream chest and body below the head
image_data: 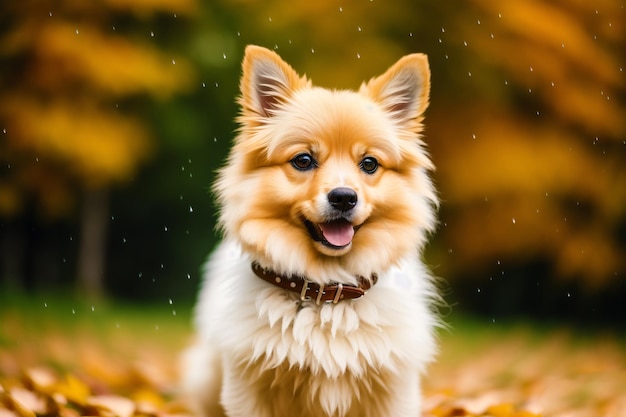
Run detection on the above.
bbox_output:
[179,243,437,417]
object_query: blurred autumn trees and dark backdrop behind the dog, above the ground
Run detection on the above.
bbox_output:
[0,0,626,326]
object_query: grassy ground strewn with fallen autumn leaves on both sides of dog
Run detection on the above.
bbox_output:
[0,298,626,417]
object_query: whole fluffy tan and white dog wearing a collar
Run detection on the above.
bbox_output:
[182,45,439,417]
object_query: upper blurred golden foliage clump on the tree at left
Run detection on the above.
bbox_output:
[28,23,192,98]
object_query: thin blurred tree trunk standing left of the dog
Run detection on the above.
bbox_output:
[78,189,109,298]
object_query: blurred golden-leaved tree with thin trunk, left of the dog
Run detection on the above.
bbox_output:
[0,0,196,295]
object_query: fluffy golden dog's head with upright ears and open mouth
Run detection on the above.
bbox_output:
[215,46,436,283]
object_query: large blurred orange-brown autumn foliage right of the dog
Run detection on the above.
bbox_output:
[431,0,626,296]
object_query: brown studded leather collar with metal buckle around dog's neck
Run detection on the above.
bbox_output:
[252,262,378,305]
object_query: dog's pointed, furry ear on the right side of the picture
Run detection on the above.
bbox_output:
[361,54,430,124]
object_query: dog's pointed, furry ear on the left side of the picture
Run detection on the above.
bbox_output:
[240,45,307,118]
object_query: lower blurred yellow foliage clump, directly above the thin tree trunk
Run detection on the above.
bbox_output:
[0,97,149,186]
